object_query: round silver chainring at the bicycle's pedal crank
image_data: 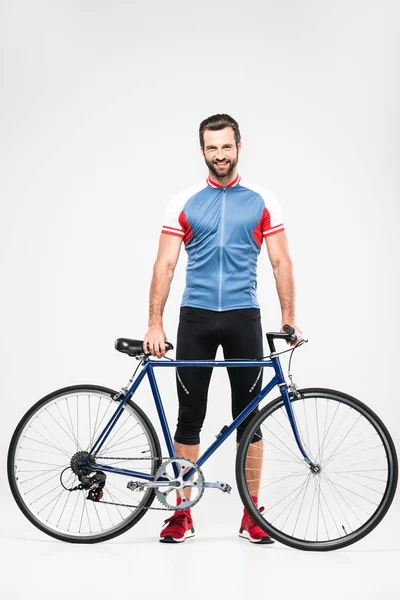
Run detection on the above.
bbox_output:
[154,458,204,510]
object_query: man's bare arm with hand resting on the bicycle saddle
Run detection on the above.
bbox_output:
[143,233,182,358]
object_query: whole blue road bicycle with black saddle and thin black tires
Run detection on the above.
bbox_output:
[8,326,398,551]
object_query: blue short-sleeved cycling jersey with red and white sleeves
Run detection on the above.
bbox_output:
[162,175,284,311]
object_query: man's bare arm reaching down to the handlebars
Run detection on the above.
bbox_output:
[265,231,301,342]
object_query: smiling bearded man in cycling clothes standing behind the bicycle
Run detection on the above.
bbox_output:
[143,114,297,544]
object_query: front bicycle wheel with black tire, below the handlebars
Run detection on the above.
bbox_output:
[236,388,398,551]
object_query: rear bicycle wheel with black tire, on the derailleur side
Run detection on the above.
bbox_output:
[7,385,161,543]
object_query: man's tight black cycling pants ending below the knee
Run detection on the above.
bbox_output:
[175,306,263,445]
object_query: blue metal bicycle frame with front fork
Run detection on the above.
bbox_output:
[85,357,314,481]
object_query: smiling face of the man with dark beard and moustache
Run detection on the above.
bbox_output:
[203,127,242,183]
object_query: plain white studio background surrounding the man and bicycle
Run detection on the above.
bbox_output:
[0,0,400,600]
